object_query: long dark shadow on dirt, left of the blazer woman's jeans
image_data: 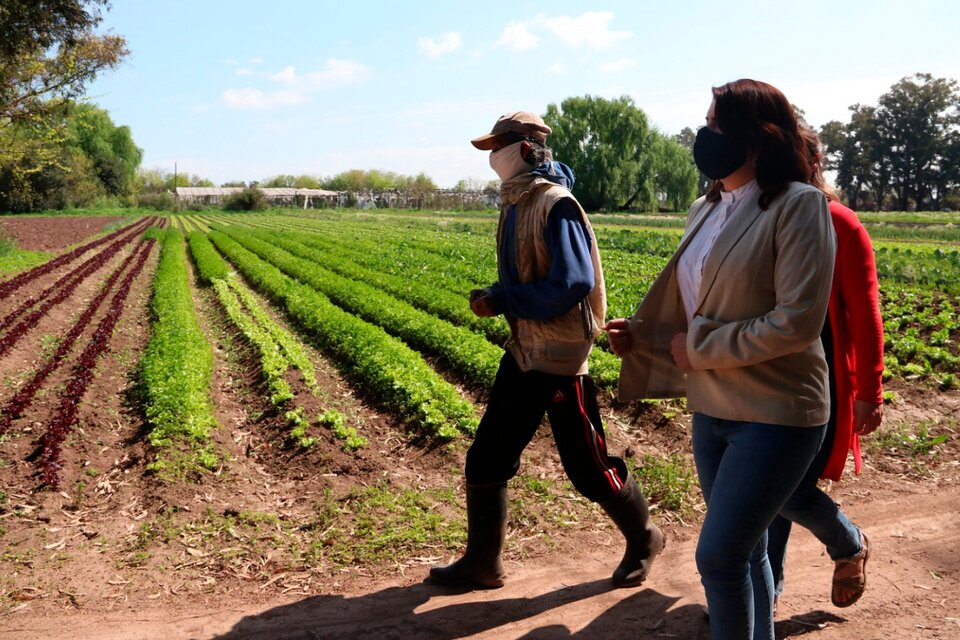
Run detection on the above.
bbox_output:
[215,580,710,640]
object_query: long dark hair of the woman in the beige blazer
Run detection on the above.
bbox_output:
[707,79,810,209]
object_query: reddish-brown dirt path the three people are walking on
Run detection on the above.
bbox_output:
[0,485,960,640]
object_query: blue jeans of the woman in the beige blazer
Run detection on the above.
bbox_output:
[693,413,824,640]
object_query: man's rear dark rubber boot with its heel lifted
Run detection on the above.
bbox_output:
[600,477,664,587]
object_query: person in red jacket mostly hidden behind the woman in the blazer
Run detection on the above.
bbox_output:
[767,126,883,607]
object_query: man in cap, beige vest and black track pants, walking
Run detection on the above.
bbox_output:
[430,111,663,588]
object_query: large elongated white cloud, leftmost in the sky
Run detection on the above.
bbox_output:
[221,58,370,109]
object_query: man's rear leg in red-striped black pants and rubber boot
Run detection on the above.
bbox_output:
[547,375,663,587]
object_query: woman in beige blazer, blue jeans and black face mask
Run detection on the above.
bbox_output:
[607,80,836,640]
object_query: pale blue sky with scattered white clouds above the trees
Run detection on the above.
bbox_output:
[88,0,960,187]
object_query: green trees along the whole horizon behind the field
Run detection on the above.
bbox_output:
[0,0,960,212]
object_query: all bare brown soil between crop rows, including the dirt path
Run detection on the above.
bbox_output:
[0,218,960,640]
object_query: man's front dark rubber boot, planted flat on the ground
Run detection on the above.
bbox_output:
[430,484,507,589]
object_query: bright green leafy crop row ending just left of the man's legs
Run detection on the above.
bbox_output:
[209,230,477,438]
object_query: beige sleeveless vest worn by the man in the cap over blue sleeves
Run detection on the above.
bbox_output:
[497,174,607,375]
